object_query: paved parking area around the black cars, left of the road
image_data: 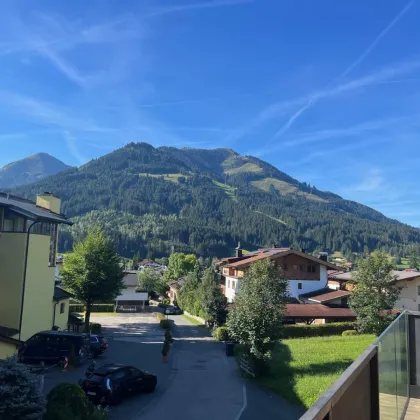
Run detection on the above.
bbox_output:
[44,314,172,420]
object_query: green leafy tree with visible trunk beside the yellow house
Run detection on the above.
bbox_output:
[60,227,124,331]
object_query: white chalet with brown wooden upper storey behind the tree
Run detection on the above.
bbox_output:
[218,246,337,303]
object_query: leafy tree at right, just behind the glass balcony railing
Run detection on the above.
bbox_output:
[350,251,400,335]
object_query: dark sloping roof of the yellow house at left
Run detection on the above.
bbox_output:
[0,192,73,225]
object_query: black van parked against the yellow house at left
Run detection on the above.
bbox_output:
[18,331,90,364]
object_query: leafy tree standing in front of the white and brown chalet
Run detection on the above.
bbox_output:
[227,259,287,360]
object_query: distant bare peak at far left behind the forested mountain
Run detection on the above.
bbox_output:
[0,153,70,188]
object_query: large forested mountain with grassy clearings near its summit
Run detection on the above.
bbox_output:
[15,143,420,257]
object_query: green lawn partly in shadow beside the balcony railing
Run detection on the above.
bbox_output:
[258,335,376,407]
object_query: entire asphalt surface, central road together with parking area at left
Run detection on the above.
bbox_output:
[44,313,304,420]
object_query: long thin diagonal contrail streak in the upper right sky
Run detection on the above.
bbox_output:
[267,0,414,141]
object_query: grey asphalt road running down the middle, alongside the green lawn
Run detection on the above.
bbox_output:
[138,315,305,420]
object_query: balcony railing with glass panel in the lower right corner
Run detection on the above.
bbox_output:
[301,311,420,420]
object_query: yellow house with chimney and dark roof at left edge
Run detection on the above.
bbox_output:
[0,192,72,358]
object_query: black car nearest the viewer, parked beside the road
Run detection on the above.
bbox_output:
[79,363,157,405]
